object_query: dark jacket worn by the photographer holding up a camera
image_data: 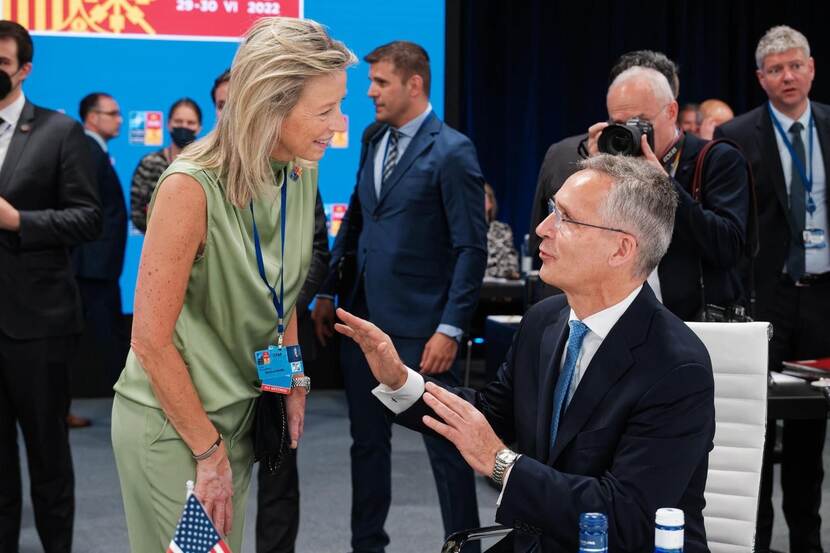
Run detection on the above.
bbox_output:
[657,133,749,321]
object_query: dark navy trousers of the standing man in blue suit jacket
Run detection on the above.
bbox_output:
[340,286,480,553]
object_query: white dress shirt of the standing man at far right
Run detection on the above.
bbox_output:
[769,102,830,274]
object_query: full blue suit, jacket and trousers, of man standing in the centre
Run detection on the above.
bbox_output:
[323,113,487,551]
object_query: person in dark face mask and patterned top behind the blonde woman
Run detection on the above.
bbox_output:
[130,98,202,232]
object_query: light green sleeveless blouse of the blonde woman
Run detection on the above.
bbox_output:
[115,160,317,413]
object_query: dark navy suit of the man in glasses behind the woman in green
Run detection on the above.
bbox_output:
[72,136,128,388]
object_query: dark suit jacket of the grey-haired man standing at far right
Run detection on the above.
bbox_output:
[715,102,830,310]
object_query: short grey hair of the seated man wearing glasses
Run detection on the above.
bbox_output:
[579,154,677,277]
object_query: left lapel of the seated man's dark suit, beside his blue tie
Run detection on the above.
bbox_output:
[536,304,571,459]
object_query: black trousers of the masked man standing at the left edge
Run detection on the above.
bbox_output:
[0,332,76,553]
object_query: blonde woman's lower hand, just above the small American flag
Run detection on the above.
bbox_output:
[193,442,233,536]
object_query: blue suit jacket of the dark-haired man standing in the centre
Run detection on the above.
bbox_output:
[331,113,487,338]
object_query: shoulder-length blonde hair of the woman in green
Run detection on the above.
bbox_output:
[180,17,357,207]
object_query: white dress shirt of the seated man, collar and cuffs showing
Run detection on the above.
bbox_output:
[372,285,643,505]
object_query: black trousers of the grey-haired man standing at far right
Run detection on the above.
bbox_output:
[755,281,830,553]
